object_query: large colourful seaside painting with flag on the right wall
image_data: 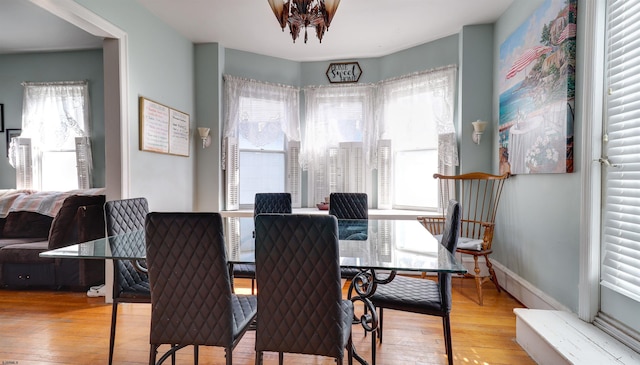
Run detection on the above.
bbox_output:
[499,0,577,174]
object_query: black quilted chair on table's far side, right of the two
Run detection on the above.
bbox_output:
[329,193,369,279]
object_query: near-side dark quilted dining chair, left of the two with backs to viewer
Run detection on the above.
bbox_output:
[145,212,257,365]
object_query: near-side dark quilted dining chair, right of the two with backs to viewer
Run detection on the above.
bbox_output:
[255,214,353,364]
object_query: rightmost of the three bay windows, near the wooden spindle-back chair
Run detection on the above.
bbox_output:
[380,67,457,210]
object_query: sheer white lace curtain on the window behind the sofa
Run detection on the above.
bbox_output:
[10,81,93,190]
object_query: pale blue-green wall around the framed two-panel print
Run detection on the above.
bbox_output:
[76,0,197,211]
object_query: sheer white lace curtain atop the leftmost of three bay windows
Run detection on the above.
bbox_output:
[222,75,300,169]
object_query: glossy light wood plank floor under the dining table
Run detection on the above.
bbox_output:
[0,278,534,365]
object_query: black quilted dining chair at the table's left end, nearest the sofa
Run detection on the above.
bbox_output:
[104,198,151,365]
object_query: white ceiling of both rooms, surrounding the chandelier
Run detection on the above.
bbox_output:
[0,0,514,61]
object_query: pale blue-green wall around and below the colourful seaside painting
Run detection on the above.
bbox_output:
[493,0,582,312]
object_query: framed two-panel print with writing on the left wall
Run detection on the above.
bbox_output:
[140,97,189,157]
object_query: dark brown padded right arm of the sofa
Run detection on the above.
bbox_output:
[49,195,105,250]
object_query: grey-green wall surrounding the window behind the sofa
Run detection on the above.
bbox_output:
[0,49,105,189]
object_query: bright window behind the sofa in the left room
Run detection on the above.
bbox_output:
[10,81,92,191]
